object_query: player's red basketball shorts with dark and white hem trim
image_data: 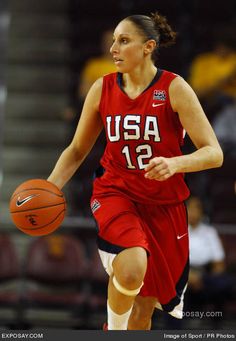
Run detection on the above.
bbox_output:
[91,195,189,318]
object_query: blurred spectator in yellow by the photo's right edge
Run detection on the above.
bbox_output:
[189,38,236,120]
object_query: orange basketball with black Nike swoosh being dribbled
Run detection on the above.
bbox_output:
[9,179,66,236]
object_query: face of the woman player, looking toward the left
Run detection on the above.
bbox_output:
[110,20,145,72]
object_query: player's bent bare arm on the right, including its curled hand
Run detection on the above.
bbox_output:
[145,77,223,181]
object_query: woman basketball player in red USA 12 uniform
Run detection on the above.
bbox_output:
[48,13,223,330]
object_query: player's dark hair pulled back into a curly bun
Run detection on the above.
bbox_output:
[124,12,177,60]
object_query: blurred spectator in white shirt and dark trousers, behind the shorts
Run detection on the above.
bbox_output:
[185,196,232,323]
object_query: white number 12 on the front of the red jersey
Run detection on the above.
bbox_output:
[121,144,152,169]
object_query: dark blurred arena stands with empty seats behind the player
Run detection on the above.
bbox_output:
[0,0,236,329]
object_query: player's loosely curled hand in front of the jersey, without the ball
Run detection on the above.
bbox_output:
[144,156,177,181]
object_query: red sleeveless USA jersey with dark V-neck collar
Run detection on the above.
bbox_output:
[94,69,189,204]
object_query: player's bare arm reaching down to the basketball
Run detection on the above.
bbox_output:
[48,78,103,188]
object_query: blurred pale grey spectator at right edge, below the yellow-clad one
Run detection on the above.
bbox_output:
[212,97,236,159]
